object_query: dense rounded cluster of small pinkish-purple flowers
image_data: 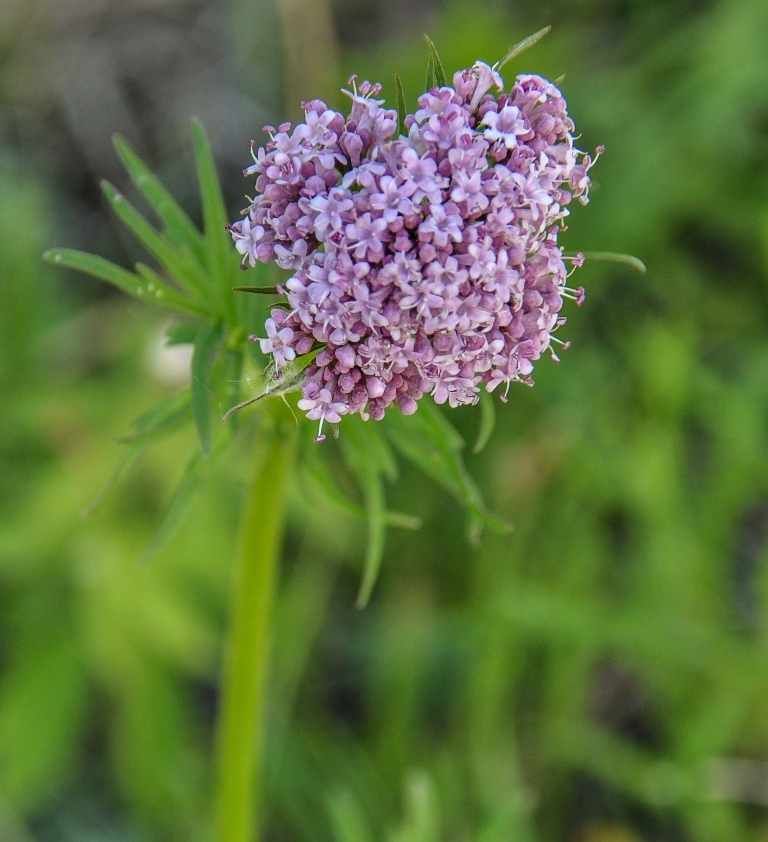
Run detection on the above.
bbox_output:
[230,62,593,439]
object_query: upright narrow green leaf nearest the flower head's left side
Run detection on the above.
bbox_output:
[192,119,236,321]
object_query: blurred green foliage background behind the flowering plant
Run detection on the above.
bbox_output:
[0,0,768,842]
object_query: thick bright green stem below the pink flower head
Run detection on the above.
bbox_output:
[216,401,296,842]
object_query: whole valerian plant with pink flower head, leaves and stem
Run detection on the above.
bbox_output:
[46,30,636,842]
